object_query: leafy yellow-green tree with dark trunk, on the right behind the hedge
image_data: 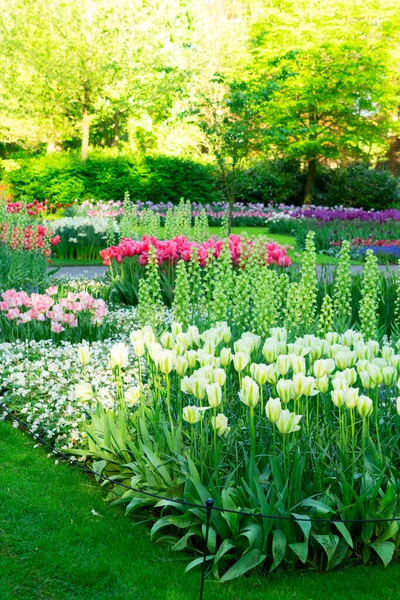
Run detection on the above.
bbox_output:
[248,0,394,203]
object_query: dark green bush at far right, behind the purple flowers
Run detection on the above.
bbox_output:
[313,163,400,210]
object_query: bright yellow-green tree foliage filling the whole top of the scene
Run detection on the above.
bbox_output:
[0,0,400,201]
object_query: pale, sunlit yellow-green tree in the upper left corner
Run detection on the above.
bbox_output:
[0,0,194,159]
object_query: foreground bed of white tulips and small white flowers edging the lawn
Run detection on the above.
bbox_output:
[2,323,400,581]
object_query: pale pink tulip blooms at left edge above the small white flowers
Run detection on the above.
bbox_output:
[0,286,107,333]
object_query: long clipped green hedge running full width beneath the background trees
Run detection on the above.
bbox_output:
[4,152,400,209]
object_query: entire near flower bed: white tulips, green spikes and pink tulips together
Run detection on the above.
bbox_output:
[0,232,400,581]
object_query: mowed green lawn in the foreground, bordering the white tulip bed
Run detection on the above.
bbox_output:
[0,423,400,600]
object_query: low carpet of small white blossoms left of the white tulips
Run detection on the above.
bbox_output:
[0,338,138,448]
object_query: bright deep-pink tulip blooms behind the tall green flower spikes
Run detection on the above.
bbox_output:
[100,235,291,267]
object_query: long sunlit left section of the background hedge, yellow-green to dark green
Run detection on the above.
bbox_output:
[6,153,221,205]
